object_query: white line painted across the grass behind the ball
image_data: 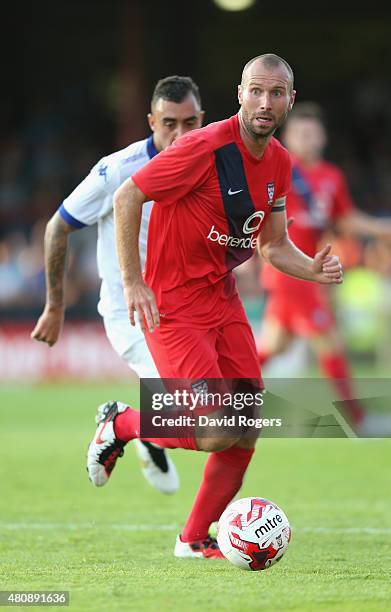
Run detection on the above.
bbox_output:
[0,523,391,535]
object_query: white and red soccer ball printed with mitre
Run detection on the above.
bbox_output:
[217,497,291,571]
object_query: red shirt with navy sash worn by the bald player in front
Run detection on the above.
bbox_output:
[132,115,291,327]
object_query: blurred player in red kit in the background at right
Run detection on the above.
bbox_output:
[258,102,391,435]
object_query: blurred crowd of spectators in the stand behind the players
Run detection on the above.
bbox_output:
[0,2,391,372]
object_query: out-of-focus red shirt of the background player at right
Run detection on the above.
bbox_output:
[261,157,354,290]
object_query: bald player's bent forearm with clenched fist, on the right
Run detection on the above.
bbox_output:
[258,212,342,285]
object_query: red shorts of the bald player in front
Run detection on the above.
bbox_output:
[145,302,264,430]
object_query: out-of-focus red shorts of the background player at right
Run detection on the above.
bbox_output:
[264,281,335,336]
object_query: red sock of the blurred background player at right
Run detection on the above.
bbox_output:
[319,353,364,424]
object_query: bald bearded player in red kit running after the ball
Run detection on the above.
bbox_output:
[88,54,342,557]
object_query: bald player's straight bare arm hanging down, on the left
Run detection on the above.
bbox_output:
[114,179,160,332]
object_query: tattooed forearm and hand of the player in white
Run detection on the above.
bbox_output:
[31,212,75,346]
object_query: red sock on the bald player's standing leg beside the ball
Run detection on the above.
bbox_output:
[181,446,254,542]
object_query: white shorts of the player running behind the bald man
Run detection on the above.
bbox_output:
[103,317,159,378]
